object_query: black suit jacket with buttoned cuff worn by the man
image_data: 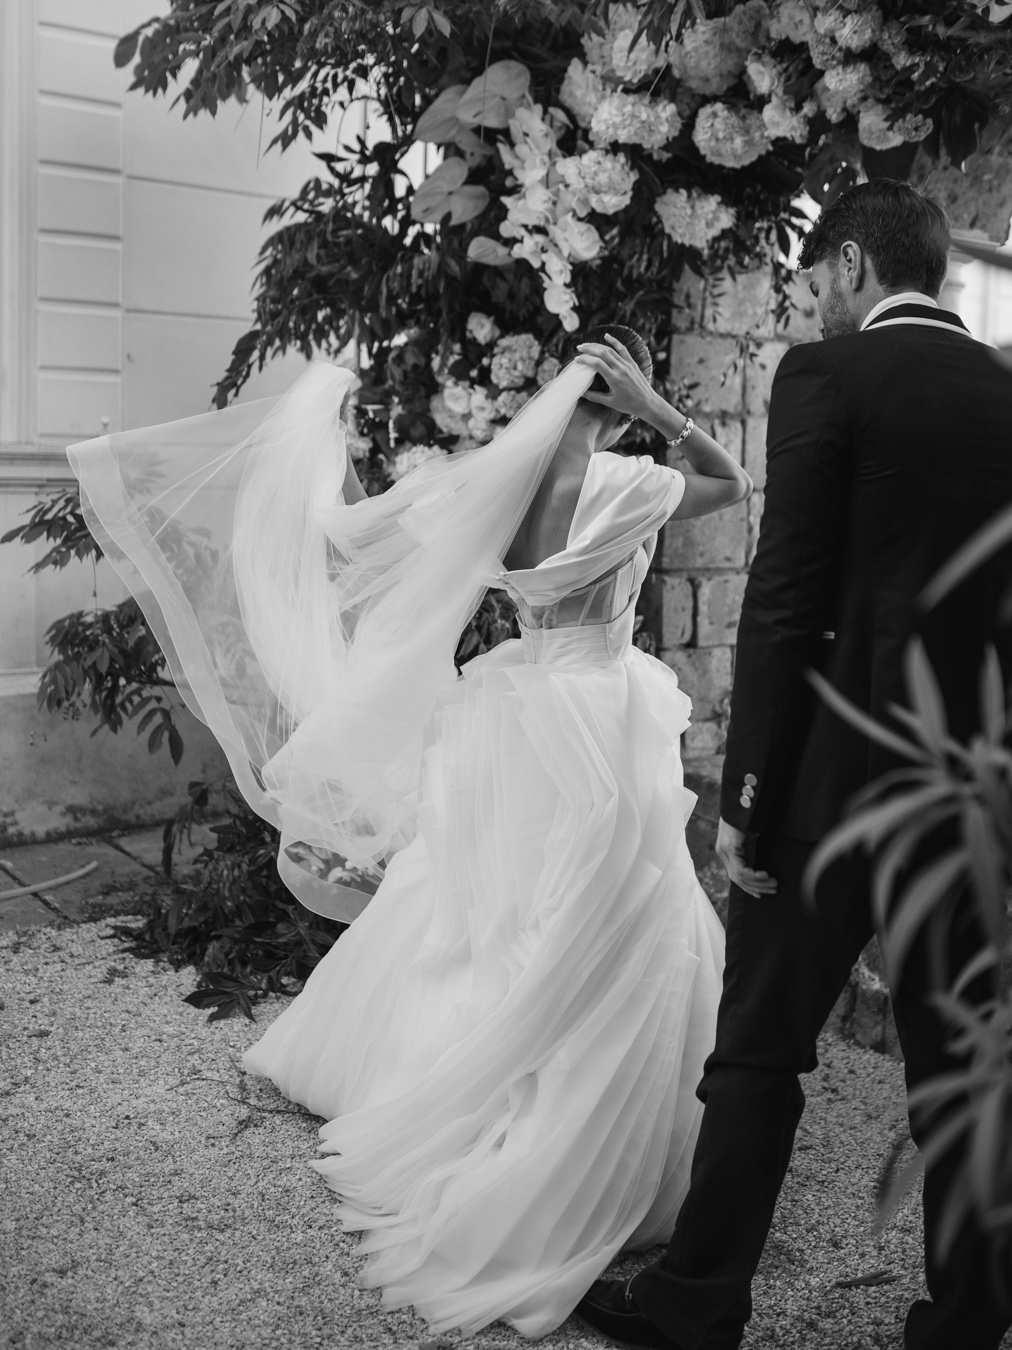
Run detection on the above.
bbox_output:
[721,304,1012,840]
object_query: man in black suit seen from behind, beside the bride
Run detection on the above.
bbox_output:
[578,180,1012,1350]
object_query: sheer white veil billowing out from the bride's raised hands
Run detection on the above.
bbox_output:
[67,360,594,922]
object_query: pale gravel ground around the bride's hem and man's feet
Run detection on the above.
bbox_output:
[0,921,1012,1350]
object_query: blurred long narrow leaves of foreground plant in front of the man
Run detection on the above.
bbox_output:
[810,510,1012,1254]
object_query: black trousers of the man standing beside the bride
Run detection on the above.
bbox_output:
[631,837,1011,1350]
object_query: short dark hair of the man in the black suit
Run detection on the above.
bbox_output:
[797,178,951,300]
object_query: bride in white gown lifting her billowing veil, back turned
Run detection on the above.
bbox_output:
[69,325,752,1337]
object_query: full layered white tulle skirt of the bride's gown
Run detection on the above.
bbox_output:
[244,640,723,1338]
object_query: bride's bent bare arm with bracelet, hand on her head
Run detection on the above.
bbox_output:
[579,335,752,520]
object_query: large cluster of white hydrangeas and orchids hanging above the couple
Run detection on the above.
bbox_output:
[407,0,1000,330]
